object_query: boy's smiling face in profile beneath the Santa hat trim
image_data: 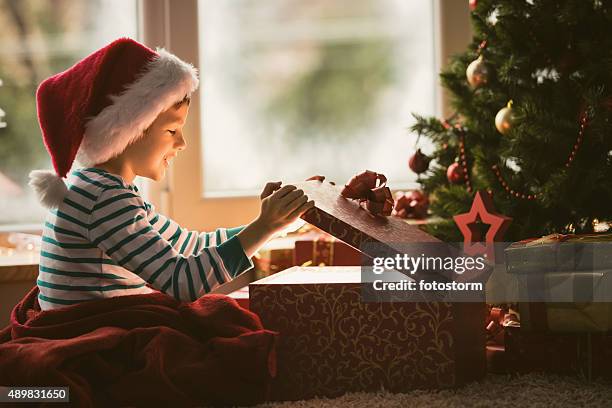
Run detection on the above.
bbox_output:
[124,103,189,180]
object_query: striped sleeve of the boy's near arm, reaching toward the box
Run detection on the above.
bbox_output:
[89,189,253,301]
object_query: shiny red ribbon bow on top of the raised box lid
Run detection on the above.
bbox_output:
[340,170,393,217]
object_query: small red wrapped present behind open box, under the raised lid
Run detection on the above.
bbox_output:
[295,233,362,266]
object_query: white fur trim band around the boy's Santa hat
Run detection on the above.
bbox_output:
[76,49,198,166]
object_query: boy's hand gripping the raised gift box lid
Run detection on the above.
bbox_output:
[257,183,314,233]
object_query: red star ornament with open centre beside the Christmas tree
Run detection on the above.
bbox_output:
[453,191,512,261]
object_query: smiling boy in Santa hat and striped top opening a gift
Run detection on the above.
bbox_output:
[30,38,313,310]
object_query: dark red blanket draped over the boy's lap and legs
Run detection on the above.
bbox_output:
[0,287,277,407]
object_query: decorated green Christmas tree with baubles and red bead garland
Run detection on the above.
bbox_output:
[411,0,612,242]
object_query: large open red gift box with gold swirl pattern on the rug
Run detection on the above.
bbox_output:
[249,266,486,400]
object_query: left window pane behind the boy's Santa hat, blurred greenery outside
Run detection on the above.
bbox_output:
[0,0,138,228]
